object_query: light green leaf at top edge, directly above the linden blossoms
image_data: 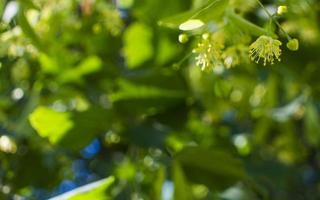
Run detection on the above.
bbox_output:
[158,0,229,28]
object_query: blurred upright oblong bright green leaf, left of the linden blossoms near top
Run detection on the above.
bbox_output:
[123,23,153,68]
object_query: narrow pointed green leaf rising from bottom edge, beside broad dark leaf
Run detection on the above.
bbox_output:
[172,162,192,200]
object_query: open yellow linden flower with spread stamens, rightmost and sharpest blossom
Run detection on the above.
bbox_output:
[249,35,282,65]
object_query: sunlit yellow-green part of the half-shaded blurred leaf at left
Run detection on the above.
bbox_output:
[29,106,74,144]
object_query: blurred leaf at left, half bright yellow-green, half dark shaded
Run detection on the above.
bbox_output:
[29,106,109,150]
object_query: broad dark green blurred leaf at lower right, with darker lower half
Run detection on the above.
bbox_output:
[175,147,246,190]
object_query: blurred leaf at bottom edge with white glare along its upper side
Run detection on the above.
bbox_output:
[50,176,115,200]
